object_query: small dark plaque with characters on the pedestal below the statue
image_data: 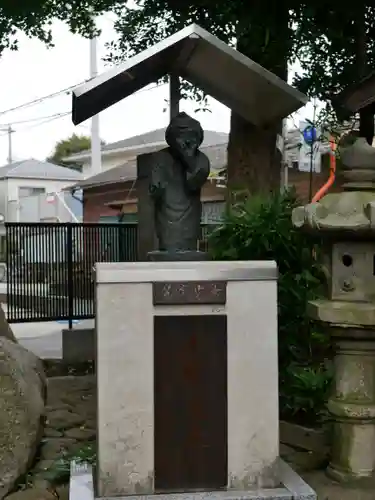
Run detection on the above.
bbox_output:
[152,281,227,306]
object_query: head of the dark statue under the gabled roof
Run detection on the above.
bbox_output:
[165,113,203,155]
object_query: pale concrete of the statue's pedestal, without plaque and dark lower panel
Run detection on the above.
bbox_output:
[96,261,279,497]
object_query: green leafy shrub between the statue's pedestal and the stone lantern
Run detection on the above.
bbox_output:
[209,192,329,423]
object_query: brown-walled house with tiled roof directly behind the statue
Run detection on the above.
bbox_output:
[64,128,228,222]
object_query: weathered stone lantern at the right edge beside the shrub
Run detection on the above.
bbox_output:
[293,138,375,481]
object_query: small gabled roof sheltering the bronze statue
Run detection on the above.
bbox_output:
[72,24,308,126]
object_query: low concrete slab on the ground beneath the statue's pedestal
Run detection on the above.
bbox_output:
[69,458,317,500]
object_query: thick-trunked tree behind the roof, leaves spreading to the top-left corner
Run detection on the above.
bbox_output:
[0,0,302,195]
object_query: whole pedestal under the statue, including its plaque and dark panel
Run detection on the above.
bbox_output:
[96,262,280,498]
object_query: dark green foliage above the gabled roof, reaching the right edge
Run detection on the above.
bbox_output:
[108,0,375,139]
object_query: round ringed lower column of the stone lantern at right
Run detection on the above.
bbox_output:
[328,327,375,481]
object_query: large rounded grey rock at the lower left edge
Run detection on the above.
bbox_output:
[0,337,46,499]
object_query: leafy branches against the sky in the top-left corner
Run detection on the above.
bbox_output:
[0,0,115,53]
